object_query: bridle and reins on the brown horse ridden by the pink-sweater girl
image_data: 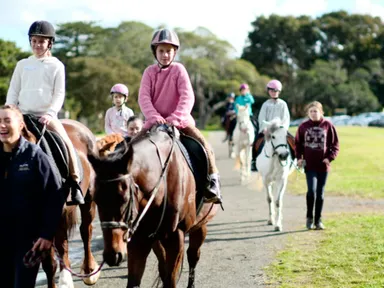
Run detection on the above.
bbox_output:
[100,129,175,242]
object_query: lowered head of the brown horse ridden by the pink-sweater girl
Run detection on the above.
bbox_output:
[88,150,132,266]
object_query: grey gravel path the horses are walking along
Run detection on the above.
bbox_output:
[37,132,384,288]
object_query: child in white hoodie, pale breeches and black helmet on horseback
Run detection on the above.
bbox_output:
[6,21,84,205]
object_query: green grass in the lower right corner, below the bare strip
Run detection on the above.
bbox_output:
[266,214,384,288]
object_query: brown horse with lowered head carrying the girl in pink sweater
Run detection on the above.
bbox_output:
[88,127,217,288]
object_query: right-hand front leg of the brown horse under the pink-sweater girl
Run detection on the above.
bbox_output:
[162,229,185,288]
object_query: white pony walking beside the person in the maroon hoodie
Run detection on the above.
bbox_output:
[256,118,296,231]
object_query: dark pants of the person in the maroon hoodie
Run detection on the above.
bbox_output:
[305,171,328,224]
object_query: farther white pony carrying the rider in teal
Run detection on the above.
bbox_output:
[233,104,255,184]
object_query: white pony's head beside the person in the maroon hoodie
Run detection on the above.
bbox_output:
[264,118,289,161]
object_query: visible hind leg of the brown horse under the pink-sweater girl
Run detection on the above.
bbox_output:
[187,225,207,288]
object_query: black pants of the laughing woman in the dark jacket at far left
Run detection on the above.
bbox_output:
[0,242,40,288]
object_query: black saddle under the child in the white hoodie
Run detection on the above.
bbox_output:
[24,114,83,183]
